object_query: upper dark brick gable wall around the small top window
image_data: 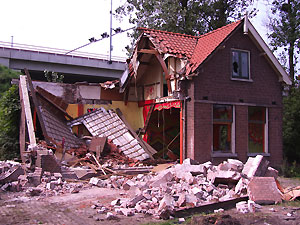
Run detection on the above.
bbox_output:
[194,29,282,105]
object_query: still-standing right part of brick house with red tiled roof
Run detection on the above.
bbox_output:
[103,17,291,165]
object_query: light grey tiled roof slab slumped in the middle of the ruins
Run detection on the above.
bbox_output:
[69,108,155,160]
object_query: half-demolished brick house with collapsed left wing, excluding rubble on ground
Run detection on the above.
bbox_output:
[20,17,291,165]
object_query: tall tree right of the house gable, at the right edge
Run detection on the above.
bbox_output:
[268,0,300,82]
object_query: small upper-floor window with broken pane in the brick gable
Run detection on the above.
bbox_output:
[232,50,249,79]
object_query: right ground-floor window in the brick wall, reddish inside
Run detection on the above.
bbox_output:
[248,106,267,153]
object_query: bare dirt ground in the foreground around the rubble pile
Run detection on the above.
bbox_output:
[0,178,300,225]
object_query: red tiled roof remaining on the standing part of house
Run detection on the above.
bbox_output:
[138,20,242,74]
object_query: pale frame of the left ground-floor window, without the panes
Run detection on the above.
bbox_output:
[211,103,235,154]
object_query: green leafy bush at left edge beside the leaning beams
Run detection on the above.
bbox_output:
[0,85,20,160]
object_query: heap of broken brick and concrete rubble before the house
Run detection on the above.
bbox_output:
[0,155,300,220]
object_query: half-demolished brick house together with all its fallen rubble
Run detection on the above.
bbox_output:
[0,17,300,219]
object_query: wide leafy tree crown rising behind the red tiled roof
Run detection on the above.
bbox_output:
[116,0,255,53]
